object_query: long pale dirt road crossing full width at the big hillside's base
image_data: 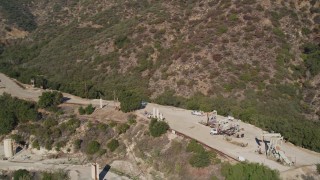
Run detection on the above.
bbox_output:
[0,73,320,172]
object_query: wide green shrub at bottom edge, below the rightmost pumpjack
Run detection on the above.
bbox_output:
[221,163,280,180]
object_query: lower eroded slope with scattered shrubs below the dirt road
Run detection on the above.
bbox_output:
[0,93,282,180]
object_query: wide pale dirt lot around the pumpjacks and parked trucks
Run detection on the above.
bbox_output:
[138,103,320,172]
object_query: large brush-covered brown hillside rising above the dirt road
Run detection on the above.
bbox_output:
[0,0,320,151]
